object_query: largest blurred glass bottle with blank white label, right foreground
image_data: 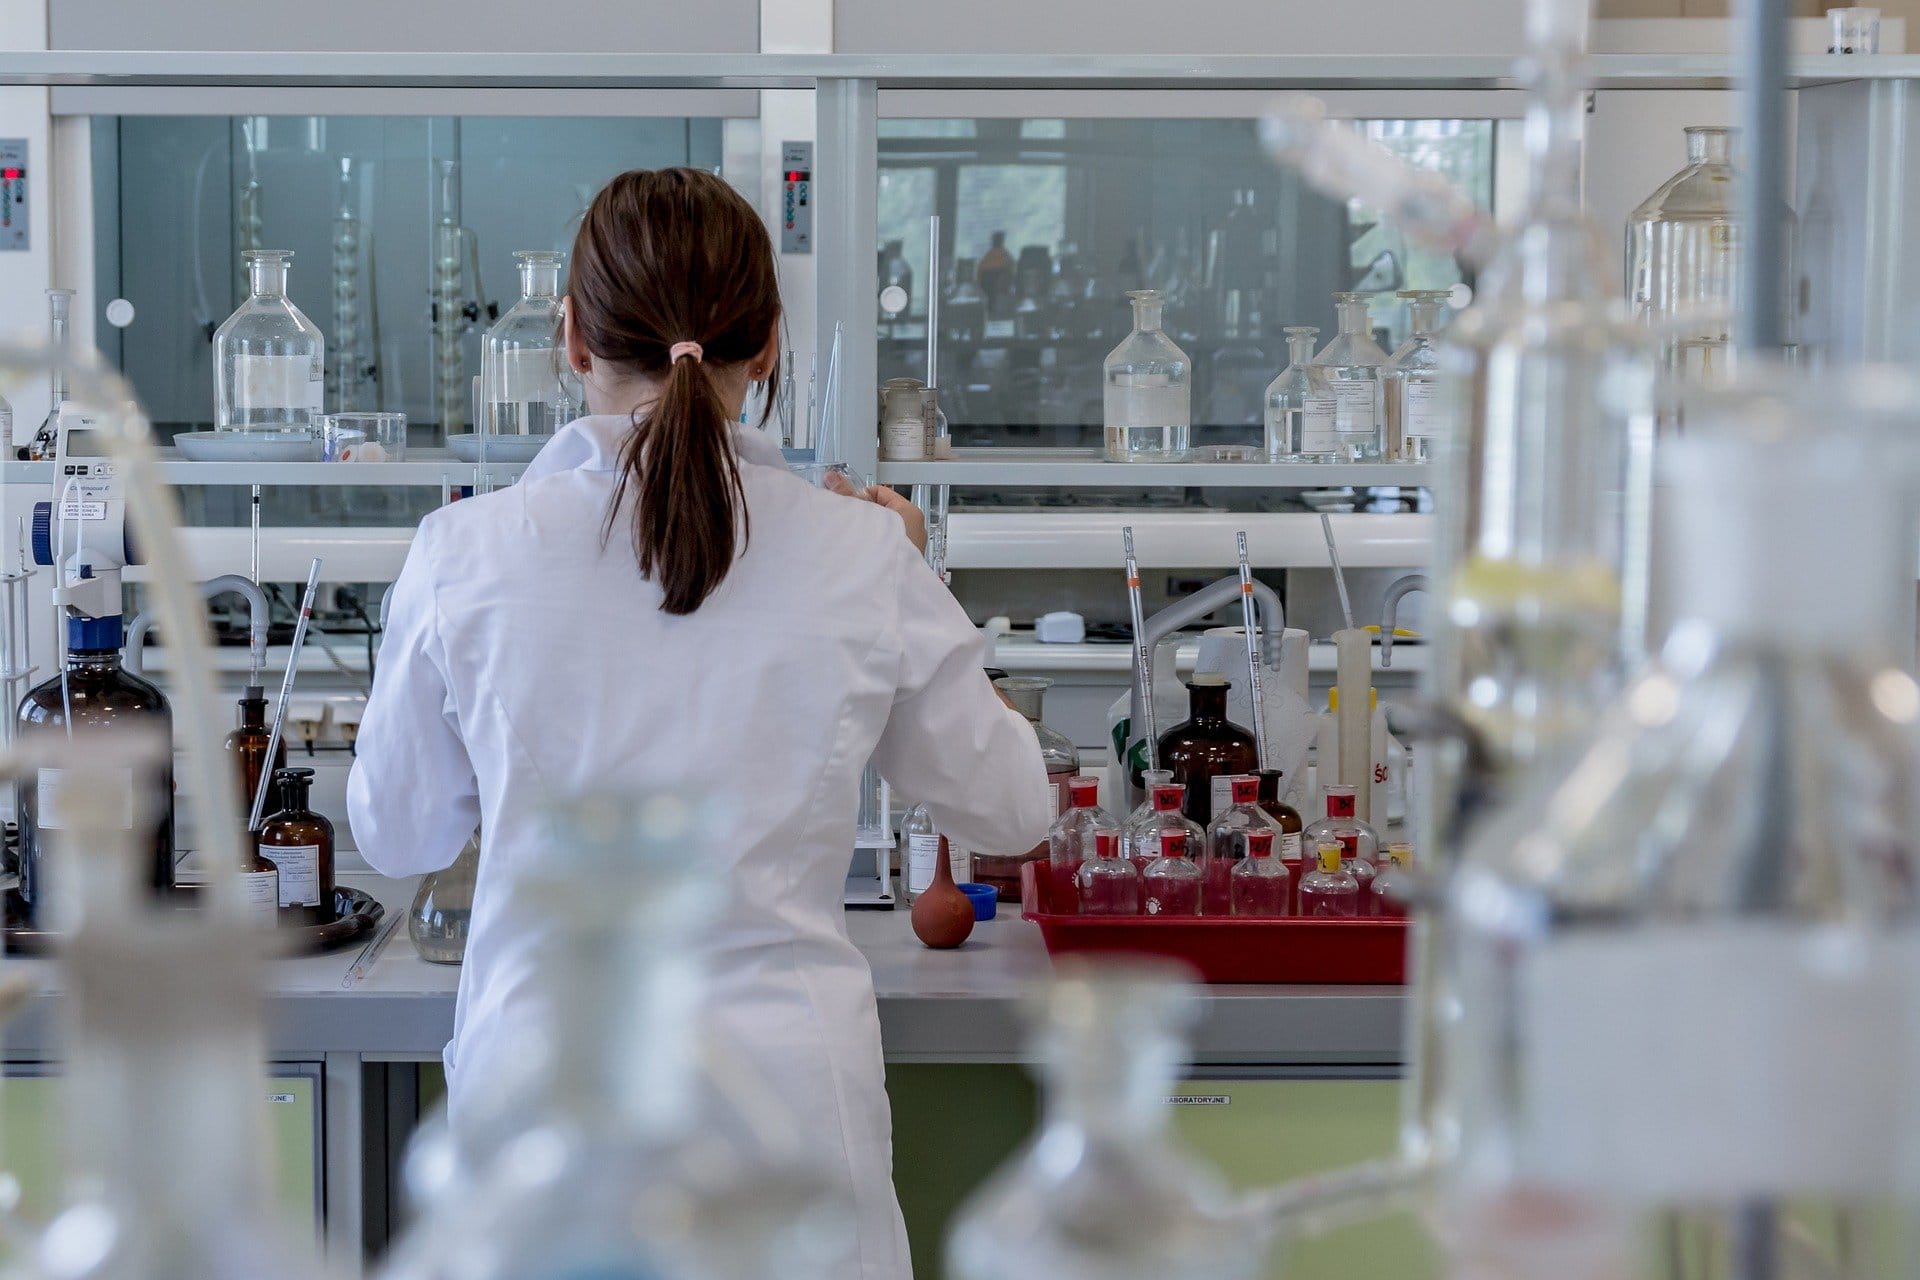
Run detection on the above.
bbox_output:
[1438,391,1920,1276]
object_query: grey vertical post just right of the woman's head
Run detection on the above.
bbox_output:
[814,79,879,485]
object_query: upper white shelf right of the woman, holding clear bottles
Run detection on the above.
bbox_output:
[874,447,1434,489]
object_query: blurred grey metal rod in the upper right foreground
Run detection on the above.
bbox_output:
[1734,0,1788,357]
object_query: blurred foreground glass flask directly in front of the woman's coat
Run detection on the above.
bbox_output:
[386,793,851,1280]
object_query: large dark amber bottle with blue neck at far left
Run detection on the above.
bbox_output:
[13,616,173,925]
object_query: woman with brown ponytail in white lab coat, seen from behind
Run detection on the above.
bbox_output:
[348,169,1052,1280]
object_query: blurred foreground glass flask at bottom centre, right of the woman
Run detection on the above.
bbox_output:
[947,958,1265,1280]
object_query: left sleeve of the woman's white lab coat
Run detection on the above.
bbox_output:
[348,520,480,877]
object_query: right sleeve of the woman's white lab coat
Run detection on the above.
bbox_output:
[874,539,1054,854]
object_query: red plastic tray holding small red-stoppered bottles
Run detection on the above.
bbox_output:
[1020,862,1407,986]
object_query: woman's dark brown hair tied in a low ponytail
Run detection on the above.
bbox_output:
[566,169,780,614]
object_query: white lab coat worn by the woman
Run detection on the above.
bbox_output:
[348,416,1052,1280]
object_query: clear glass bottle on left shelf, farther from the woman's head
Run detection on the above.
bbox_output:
[213,249,326,430]
